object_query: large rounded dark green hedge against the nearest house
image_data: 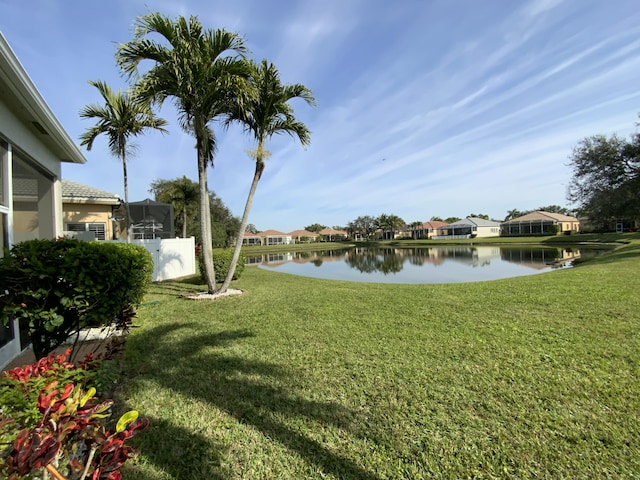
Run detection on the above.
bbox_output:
[0,240,153,358]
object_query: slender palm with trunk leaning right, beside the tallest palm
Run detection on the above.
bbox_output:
[220,60,315,292]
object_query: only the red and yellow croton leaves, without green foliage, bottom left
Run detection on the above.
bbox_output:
[0,355,149,480]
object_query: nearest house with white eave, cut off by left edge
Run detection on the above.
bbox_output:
[0,33,86,368]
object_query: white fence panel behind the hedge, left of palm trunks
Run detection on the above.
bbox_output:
[109,237,196,282]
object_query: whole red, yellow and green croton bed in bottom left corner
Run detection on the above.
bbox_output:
[0,350,149,480]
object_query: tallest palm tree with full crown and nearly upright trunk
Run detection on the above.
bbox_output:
[116,13,248,293]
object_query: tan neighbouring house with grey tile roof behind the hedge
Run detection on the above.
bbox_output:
[62,179,124,240]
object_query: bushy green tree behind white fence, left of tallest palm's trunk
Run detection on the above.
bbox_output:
[149,176,199,238]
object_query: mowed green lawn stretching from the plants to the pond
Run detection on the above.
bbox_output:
[119,234,640,479]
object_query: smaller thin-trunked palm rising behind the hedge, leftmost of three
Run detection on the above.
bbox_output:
[80,80,167,244]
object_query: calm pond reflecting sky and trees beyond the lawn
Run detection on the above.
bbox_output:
[246,246,609,284]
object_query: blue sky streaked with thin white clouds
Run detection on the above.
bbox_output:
[0,0,640,231]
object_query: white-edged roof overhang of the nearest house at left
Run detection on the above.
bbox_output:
[0,32,86,163]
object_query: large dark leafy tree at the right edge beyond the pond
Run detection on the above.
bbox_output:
[567,134,640,227]
